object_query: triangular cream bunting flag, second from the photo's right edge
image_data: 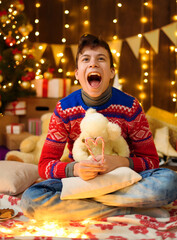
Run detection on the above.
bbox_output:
[143,29,160,53]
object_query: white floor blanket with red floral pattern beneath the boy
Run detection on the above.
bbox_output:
[0,194,177,240]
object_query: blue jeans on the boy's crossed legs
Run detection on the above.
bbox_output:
[21,168,177,221]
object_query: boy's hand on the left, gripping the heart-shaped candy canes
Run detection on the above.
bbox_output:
[74,159,106,181]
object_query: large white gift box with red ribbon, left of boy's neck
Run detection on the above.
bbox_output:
[33,78,71,98]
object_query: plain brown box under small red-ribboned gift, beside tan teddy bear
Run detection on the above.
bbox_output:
[4,132,31,150]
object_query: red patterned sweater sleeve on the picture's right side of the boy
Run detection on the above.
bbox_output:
[128,100,159,172]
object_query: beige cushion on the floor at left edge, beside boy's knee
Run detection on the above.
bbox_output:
[0,161,39,195]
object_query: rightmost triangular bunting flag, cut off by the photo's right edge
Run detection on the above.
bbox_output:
[161,22,177,46]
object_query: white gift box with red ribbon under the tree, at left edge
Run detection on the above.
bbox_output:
[4,101,26,115]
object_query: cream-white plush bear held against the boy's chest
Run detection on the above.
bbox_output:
[72,108,130,162]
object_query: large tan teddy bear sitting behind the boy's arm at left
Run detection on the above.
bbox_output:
[5,113,52,164]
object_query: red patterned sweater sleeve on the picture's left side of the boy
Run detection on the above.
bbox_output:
[38,106,72,179]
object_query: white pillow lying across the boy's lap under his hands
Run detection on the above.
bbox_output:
[60,167,142,200]
